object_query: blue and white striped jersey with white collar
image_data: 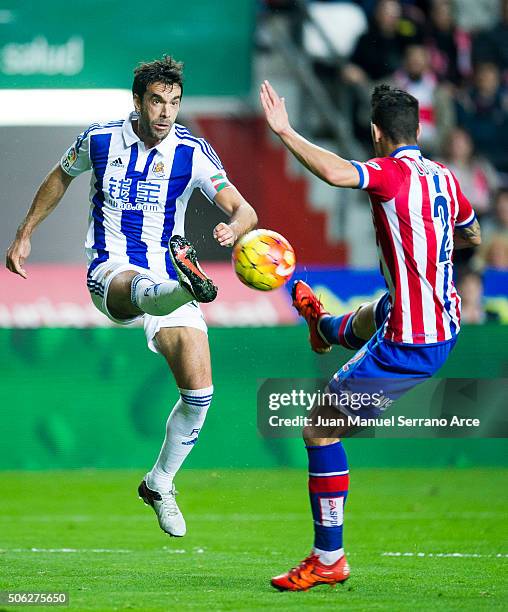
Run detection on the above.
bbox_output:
[60,113,229,279]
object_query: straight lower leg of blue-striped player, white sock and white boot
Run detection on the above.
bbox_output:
[139,327,213,536]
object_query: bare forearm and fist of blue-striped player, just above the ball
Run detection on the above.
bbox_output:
[213,185,258,247]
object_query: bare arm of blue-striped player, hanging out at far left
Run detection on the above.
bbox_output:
[5,164,74,278]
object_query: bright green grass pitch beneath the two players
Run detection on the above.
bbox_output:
[0,469,508,612]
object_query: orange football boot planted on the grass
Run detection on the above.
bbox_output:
[271,554,349,591]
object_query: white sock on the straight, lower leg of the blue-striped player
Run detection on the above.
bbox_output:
[146,386,213,492]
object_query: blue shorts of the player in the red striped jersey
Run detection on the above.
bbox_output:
[327,329,457,418]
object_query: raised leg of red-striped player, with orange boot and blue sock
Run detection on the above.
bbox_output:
[292,281,390,353]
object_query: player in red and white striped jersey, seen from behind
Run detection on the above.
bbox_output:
[260,81,481,591]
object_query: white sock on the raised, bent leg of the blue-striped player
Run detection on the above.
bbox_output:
[131,274,194,317]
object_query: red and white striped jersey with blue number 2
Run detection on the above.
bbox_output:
[352,146,475,344]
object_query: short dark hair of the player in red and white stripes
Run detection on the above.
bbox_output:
[371,85,419,144]
